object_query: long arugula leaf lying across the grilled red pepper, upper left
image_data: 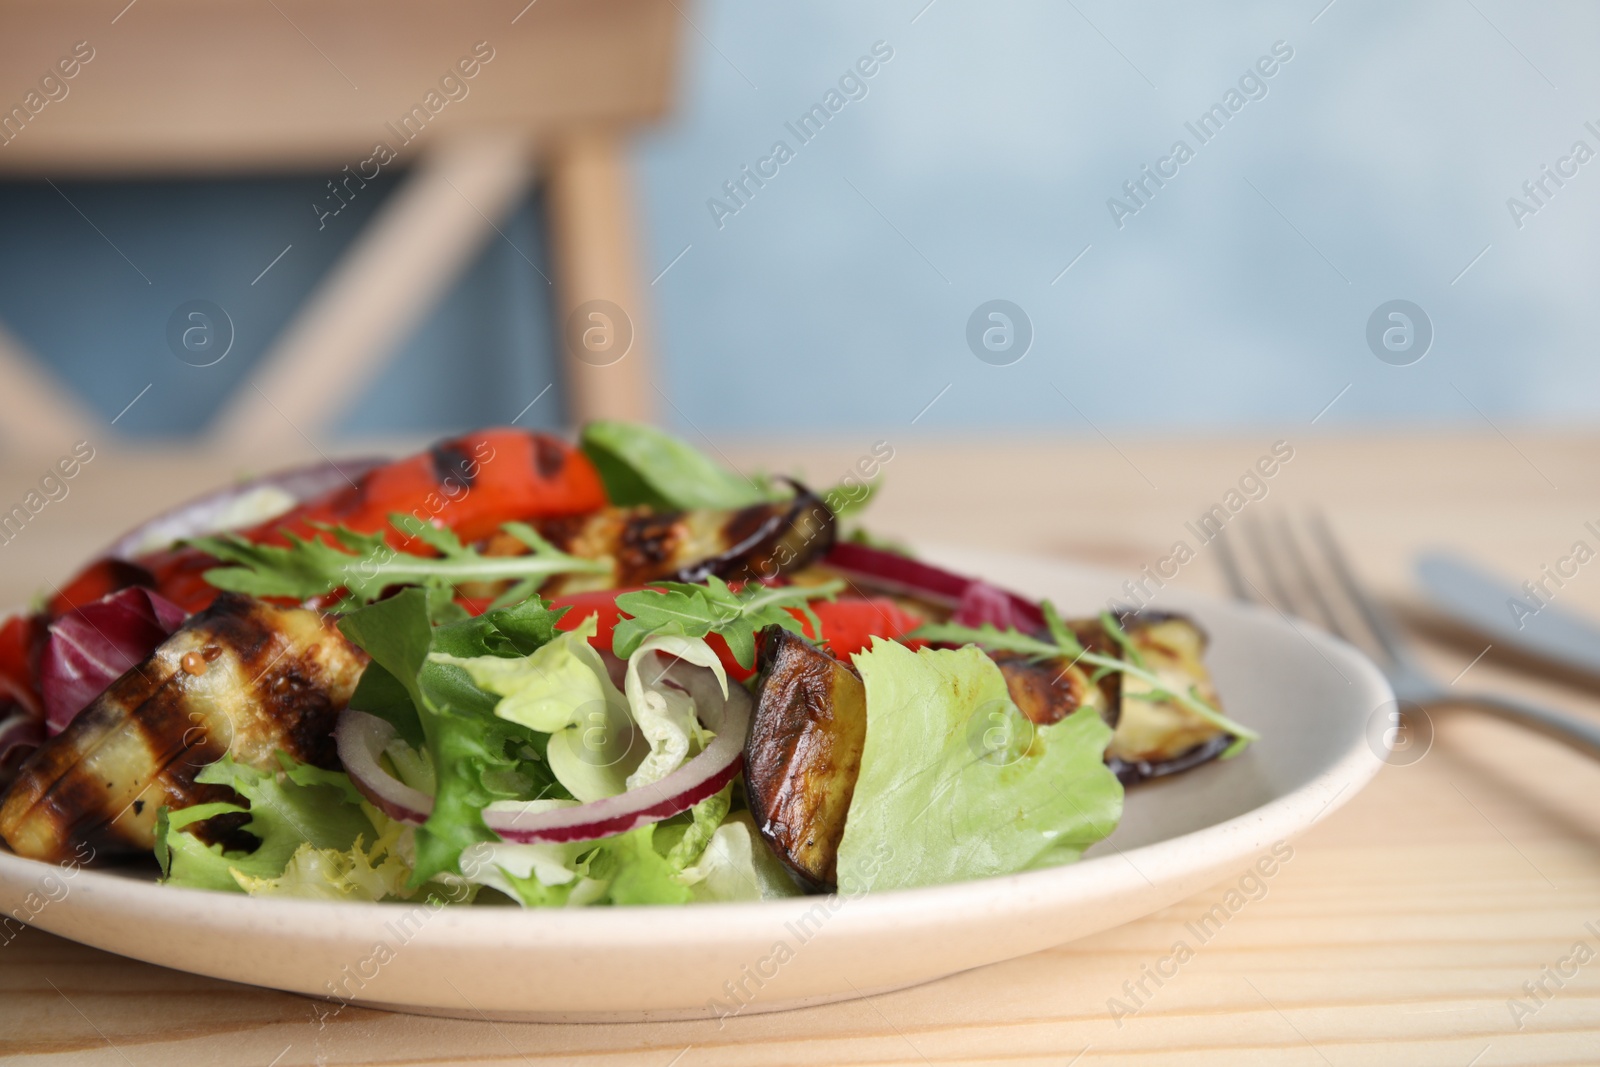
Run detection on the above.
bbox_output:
[187,512,611,619]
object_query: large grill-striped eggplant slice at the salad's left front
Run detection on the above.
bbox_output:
[0,593,366,861]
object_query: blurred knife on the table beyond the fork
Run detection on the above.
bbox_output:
[1414,552,1600,675]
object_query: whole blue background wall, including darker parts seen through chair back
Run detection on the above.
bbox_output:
[0,0,1600,435]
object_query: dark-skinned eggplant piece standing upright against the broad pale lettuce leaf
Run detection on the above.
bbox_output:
[744,627,867,889]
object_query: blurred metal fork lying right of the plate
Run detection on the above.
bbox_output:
[1216,515,1600,758]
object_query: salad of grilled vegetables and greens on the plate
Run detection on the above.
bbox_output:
[0,422,1256,907]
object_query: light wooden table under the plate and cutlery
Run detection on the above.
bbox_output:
[0,434,1600,1067]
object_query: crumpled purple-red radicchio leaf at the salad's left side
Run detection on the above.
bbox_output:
[38,585,186,736]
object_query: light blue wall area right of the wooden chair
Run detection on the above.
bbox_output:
[640,0,1600,432]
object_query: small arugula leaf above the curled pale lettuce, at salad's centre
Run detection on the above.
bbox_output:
[611,574,845,669]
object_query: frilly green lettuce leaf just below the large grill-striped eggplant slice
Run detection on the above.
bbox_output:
[155,753,378,893]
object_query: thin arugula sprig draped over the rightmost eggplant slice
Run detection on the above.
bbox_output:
[906,600,1261,760]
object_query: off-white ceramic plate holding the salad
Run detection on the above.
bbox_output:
[0,550,1394,1021]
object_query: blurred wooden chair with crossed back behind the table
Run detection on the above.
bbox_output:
[0,0,678,450]
